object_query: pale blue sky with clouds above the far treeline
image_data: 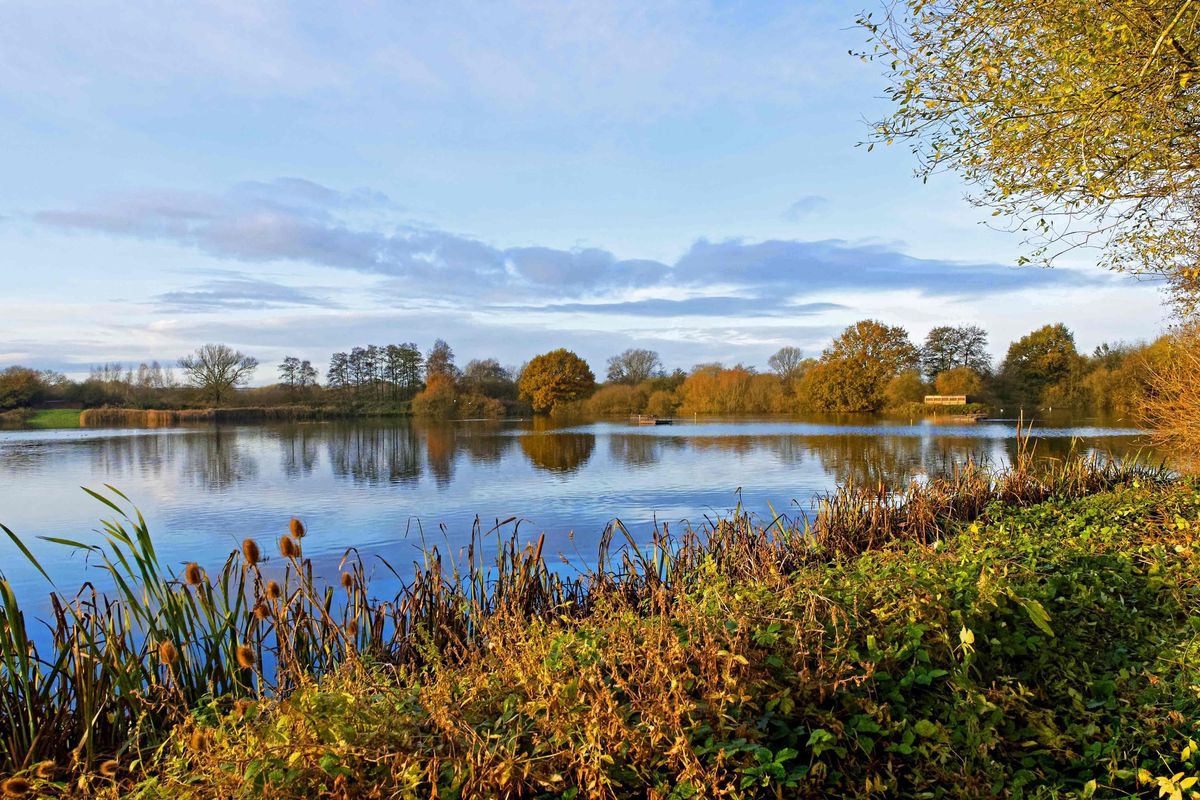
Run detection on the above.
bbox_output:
[0,0,1168,383]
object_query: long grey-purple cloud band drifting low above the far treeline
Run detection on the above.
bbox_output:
[36,179,1109,315]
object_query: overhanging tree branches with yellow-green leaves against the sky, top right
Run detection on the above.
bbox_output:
[859,0,1200,309]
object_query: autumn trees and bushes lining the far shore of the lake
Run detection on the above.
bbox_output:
[0,320,1194,425]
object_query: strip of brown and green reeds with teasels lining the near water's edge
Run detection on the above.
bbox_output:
[0,434,1172,775]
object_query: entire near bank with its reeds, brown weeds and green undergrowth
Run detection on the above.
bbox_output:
[0,459,1200,799]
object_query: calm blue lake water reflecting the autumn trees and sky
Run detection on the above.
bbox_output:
[0,420,1145,604]
